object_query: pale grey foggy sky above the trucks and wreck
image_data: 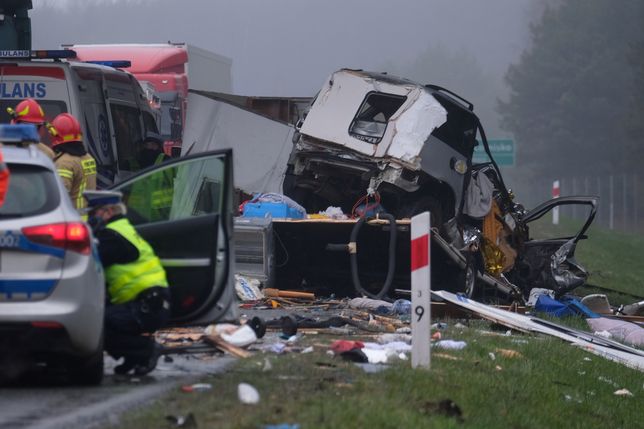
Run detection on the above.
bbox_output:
[31,0,541,96]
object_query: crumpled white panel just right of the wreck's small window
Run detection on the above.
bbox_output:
[387,91,447,163]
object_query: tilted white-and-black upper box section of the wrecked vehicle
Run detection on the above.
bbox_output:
[284,69,478,223]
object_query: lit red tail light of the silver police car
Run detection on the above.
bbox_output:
[22,222,91,255]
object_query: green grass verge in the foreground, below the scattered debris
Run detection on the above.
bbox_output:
[113,322,644,429]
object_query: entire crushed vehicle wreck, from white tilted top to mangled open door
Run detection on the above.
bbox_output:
[284,69,598,301]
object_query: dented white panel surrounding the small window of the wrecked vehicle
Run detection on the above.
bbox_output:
[300,69,447,168]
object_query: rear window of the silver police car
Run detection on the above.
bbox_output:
[0,163,60,218]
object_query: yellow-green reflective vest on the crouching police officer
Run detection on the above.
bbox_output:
[105,218,168,304]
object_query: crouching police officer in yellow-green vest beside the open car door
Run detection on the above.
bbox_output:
[84,191,170,375]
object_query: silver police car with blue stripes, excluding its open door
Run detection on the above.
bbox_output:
[0,124,105,384]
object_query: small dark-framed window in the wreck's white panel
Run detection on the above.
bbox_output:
[349,92,407,144]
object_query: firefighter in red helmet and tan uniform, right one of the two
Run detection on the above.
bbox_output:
[48,113,96,209]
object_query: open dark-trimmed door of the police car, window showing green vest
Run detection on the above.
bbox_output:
[111,150,236,325]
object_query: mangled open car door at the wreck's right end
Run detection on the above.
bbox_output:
[511,197,598,296]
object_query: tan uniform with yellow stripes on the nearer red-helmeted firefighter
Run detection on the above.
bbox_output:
[54,142,96,209]
